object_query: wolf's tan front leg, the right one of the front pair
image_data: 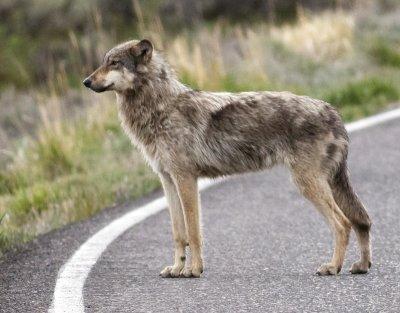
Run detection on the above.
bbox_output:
[173,176,203,277]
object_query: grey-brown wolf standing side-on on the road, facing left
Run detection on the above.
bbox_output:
[83,40,371,277]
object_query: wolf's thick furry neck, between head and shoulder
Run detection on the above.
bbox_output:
[117,78,190,144]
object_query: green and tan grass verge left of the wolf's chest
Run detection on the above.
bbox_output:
[0,104,159,254]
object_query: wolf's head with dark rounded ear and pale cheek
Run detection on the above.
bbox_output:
[83,39,155,93]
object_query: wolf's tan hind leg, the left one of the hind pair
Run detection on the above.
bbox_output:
[293,168,351,275]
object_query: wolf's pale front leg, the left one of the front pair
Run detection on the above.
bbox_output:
[160,174,187,277]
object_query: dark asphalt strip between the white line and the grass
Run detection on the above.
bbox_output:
[0,191,162,313]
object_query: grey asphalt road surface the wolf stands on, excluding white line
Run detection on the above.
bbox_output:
[0,119,400,312]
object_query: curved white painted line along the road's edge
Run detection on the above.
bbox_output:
[49,108,400,313]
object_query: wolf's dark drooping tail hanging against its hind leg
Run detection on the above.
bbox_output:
[329,158,371,233]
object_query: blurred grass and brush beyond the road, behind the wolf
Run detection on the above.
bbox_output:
[0,1,400,255]
